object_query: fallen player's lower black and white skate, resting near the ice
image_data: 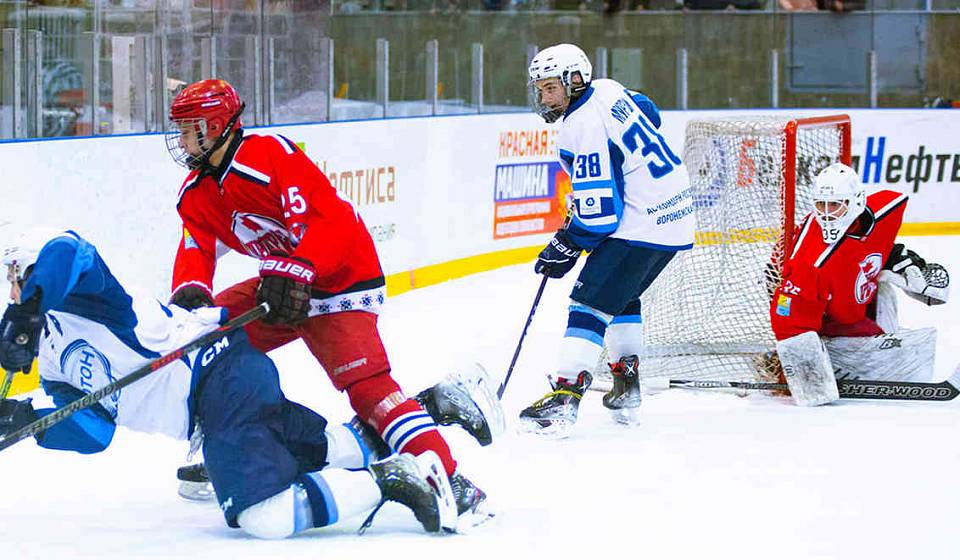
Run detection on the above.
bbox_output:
[359,451,457,534]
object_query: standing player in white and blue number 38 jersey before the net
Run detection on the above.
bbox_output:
[520,44,695,433]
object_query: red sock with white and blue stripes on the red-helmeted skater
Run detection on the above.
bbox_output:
[347,373,457,476]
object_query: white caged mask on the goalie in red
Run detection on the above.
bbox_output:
[812,163,867,243]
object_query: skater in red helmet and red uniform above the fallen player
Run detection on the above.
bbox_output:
[167,80,485,513]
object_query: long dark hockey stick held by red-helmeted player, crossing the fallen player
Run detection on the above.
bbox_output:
[0,303,270,451]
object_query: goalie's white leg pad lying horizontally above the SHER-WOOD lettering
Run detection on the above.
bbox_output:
[824,327,937,382]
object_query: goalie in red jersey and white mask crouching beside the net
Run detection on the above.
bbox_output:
[770,163,950,405]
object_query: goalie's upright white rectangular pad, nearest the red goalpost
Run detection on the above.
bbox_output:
[777,331,840,406]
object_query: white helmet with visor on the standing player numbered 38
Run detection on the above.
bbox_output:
[527,43,593,123]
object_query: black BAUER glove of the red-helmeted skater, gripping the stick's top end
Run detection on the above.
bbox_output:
[257,255,317,325]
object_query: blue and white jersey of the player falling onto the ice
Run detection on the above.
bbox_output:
[22,232,226,453]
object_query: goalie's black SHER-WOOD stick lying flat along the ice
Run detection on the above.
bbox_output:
[668,370,960,402]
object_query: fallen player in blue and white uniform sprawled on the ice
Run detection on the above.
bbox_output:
[0,231,498,538]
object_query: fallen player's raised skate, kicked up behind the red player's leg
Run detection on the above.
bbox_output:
[414,364,504,445]
